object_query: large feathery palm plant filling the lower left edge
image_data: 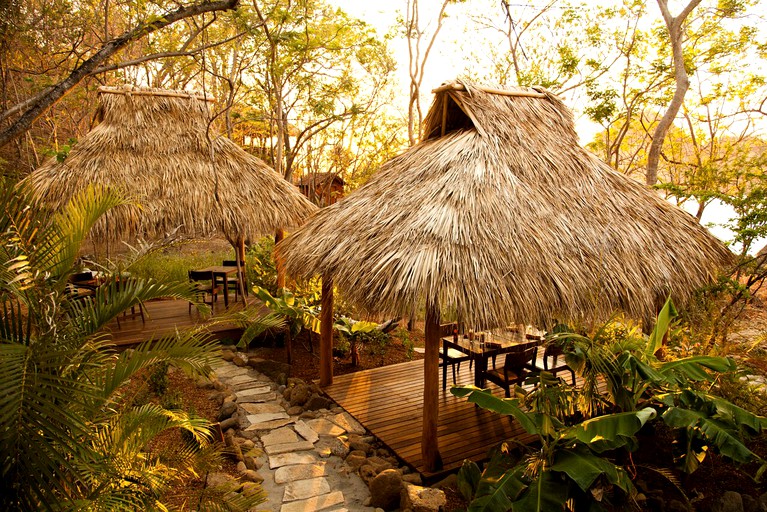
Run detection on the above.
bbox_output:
[0,183,264,510]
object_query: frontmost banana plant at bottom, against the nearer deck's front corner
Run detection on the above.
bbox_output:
[451,384,655,512]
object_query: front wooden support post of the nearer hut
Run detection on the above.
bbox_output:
[421,301,442,472]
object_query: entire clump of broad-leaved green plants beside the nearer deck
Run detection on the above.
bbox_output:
[451,299,767,511]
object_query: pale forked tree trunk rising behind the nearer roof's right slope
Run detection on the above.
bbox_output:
[645,0,701,187]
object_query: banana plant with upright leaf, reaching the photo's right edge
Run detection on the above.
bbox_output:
[567,299,767,474]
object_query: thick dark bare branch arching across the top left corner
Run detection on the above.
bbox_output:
[0,0,239,147]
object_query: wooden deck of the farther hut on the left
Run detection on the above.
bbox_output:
[105,297,264,346]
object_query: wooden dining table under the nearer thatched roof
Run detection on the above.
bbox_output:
[442,330,543,388]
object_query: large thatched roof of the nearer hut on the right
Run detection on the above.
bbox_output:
[278,80,730,326]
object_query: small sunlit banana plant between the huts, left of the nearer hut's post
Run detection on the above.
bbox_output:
[254,287,320,364]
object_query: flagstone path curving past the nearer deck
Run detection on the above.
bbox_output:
[215,363,380,512]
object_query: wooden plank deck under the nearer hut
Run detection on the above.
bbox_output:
[324,360,534,481]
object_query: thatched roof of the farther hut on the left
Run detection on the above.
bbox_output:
[28,87,316,241]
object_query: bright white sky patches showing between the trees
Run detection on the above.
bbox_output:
[328,0,764,250]
